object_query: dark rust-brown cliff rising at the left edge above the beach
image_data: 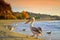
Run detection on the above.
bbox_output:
[0,0,16,19]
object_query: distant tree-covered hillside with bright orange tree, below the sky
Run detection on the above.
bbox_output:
[14,11,60,20]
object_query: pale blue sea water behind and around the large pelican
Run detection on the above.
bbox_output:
[12,20,60,40]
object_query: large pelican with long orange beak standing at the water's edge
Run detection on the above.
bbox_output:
[25,17,42,38]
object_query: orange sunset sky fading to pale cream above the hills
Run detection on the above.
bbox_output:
[5,0,60,16]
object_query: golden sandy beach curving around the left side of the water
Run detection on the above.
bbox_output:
[0,20,47,40]
